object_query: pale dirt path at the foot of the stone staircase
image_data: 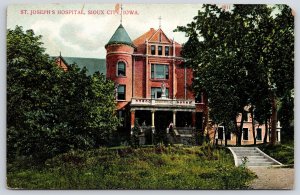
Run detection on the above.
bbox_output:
[249,167,295,189]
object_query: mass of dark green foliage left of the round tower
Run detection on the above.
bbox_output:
[7,26,119,161]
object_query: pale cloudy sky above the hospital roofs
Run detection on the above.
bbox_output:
[7,4,207,58]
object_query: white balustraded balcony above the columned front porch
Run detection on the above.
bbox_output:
[131,98,195,107]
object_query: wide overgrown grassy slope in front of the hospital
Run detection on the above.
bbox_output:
[7,145,255,189]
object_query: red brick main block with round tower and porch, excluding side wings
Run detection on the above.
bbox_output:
[105,24,205,143]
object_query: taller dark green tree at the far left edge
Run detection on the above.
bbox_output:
[7,26,64,158]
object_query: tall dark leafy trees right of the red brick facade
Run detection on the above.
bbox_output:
[177,5,293,144]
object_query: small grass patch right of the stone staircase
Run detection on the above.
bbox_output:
[259,142,294,165]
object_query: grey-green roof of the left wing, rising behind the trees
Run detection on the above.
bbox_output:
[53,56,106,75]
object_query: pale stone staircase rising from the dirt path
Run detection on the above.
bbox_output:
[228,147,282,167]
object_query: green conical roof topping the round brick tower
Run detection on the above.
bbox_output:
[105,24,135,47]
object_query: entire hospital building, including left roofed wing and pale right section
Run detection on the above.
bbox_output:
[55,24,280,145]
